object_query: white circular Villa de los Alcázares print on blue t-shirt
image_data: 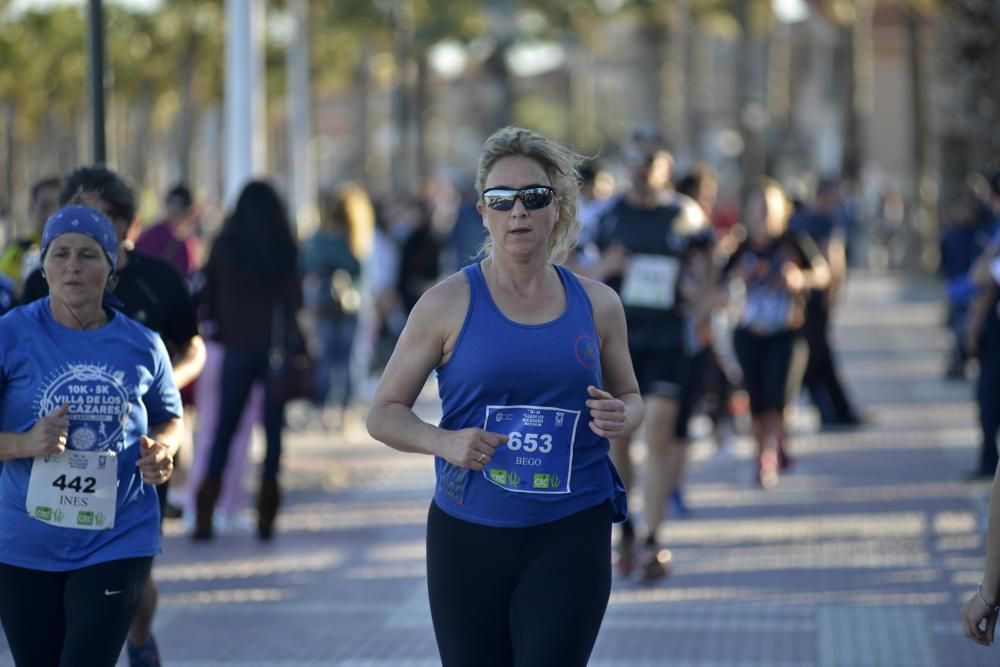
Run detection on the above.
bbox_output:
[38,364,129,451]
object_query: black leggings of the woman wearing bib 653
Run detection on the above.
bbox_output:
[427,503,611,667]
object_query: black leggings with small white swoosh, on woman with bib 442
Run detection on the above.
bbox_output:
[0,558,153,667]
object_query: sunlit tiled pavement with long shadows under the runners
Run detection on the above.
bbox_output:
[0,274,1000,667]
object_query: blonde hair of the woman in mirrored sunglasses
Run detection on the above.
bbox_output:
[476,127,584,264]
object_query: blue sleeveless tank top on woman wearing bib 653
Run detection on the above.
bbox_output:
[434,263,626,527]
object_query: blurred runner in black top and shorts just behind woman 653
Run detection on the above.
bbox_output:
[595,133,704,579]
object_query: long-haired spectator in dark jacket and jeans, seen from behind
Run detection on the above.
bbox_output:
[193,181,302,540]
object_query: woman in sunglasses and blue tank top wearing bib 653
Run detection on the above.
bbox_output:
[368,127,642,666]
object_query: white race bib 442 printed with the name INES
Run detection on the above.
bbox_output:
[27,450,118,530]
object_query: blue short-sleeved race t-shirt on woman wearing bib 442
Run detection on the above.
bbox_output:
[0,298,182,572]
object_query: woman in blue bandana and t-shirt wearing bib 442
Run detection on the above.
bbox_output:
[0,206,182,667]
